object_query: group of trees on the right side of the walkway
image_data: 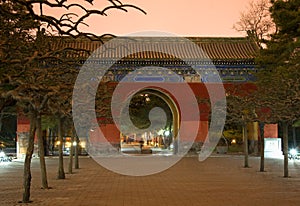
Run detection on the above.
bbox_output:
[233,0,300,177]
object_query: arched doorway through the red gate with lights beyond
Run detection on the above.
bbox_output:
[120,88,180,154]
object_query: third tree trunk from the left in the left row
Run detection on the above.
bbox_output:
[57,117,65,179]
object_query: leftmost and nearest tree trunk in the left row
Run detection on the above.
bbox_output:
[22,117,36,203]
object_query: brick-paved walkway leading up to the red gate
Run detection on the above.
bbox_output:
[0,155,300,206]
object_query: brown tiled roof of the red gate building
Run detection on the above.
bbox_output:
[53,37,258,61]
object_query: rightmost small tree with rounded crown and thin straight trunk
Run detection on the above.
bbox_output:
[258,65,300,177]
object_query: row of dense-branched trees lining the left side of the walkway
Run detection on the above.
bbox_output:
[0,0,145,203]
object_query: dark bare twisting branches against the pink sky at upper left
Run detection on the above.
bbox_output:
[15,0,146,41]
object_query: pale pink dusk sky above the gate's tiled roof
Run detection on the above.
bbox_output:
[42,0,250,37]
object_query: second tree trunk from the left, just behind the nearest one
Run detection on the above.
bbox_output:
[36,114,48,189]
